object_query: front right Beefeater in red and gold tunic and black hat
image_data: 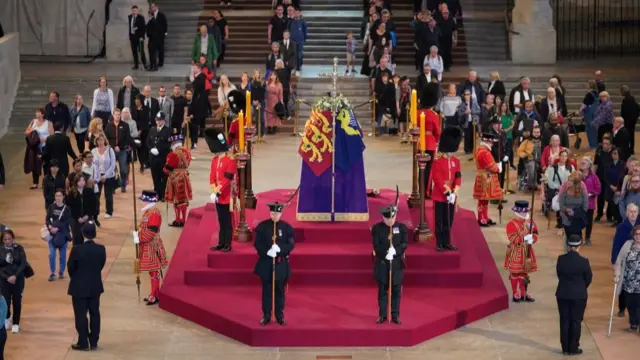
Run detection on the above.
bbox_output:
[504,200,538,302]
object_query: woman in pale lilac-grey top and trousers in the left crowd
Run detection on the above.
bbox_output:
[91,136,118,221]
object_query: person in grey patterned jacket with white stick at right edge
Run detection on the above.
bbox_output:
[613,226,640,332]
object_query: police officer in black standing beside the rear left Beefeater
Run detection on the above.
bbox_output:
[147,111,171,201]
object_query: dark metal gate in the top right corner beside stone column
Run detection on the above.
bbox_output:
[551,0,640,60]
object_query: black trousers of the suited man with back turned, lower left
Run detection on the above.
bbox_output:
[71,296,100,347]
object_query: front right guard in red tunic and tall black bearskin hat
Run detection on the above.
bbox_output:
[428,127,462,251]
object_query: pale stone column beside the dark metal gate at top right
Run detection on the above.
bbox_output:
[511,0,556,65]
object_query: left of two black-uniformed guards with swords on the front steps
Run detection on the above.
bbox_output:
[253,202,294,326]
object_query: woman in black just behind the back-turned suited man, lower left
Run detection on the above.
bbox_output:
[67,171,95,245]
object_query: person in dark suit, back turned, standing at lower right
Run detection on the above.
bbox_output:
[556,234,593,355]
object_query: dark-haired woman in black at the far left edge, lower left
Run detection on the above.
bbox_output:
[0,230,28,334]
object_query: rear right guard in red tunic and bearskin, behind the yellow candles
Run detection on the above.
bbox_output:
[417,83,441,189]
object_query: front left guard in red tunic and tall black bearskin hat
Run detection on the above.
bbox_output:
[204,128,237,252]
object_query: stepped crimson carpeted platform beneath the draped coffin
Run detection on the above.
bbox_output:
[160,189,508,347]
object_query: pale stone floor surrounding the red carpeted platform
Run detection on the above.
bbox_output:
[0,127,640,360]
